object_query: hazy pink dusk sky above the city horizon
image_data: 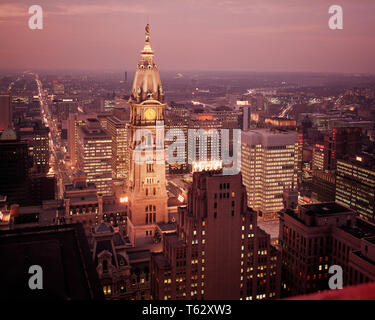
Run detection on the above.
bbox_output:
[0,0,375,73]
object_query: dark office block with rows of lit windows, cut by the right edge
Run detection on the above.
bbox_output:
[336,154,375,221]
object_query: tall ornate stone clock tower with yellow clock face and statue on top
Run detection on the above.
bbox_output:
[126,24,168,241]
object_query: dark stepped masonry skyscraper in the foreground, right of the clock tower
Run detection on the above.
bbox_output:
[151,171,280,300]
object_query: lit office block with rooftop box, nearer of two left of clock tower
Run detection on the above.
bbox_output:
[78,118,113,195]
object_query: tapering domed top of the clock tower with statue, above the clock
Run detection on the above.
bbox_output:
[130,24,164,103]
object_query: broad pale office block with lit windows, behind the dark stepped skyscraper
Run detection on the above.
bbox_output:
[241,129,298,218]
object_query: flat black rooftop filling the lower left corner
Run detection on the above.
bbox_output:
[0,224,104,300]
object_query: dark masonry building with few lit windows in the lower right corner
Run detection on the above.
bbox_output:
[279,202,375,297]
